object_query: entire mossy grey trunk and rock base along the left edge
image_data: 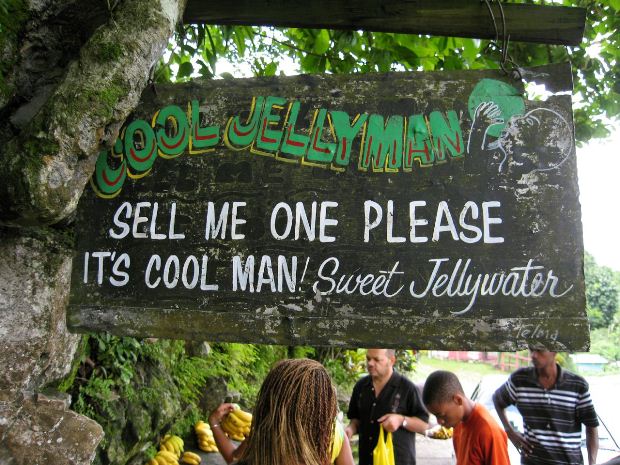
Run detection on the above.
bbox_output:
[0,0,185,465]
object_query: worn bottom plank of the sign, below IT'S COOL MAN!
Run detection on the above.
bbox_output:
[67,307,589,352]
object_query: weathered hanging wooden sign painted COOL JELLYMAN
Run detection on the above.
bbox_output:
[68,65,589,351]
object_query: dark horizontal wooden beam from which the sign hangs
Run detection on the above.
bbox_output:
[184,0,586,45]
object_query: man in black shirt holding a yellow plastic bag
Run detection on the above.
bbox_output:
[345,349,428,465]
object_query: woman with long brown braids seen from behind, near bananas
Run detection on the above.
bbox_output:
[209,359,353,465]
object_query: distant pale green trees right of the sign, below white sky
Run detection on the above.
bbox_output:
[584,253,620,329]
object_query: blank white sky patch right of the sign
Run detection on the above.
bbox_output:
[577,127,620,271]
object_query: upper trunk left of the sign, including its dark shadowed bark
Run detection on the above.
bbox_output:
[0,0,185,226]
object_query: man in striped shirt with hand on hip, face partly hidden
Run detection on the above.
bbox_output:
[493,347,598,465]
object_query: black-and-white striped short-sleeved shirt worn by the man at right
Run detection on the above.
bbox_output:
[493,365,598,465]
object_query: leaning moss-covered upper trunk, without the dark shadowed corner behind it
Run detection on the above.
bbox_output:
[0,0,185,226]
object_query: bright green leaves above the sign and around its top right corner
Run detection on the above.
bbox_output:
[155,0,620,142]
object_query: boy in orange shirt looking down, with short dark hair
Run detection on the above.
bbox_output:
[422,371,510,465]
